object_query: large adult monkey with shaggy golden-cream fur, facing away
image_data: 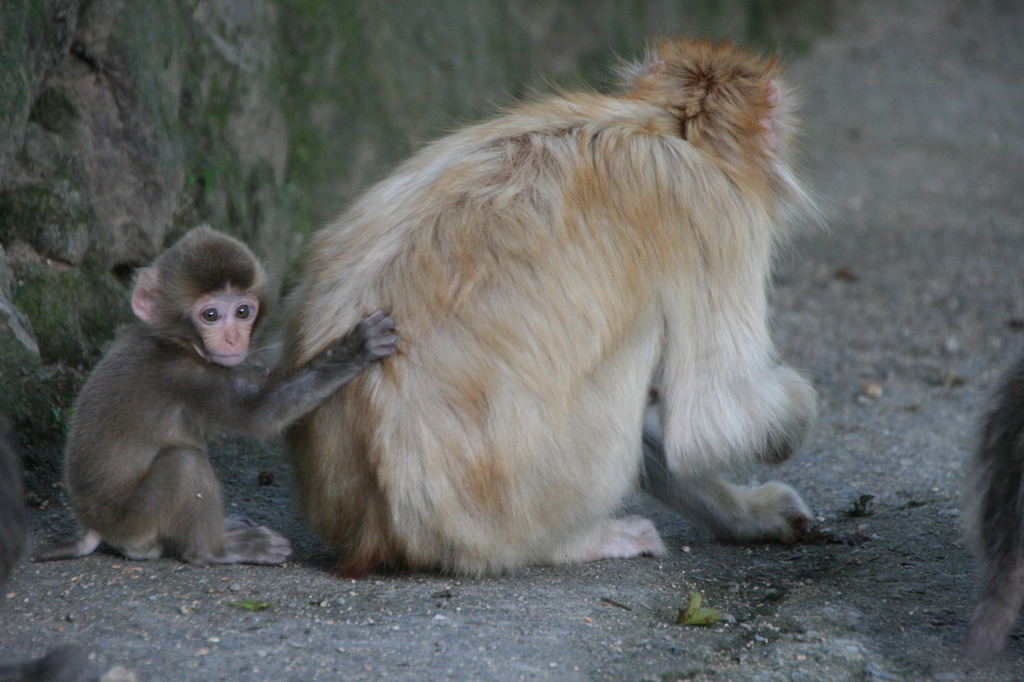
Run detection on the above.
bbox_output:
[286,41,816,574]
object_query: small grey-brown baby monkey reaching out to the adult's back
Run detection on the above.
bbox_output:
[36,227,397,564]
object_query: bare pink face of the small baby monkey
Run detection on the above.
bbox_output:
[191,289,259,367]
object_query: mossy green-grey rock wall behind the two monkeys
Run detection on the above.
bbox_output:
[0,0,830,450]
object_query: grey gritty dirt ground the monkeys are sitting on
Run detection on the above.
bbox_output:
[0,0,1024,680]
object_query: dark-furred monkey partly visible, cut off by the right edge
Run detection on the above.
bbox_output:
[965,350,1024,662]
